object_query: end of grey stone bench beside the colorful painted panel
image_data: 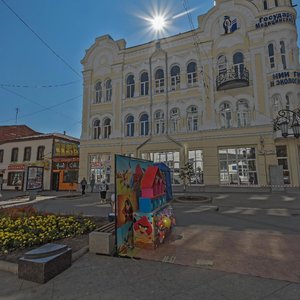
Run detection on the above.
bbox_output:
[89,222,115,255]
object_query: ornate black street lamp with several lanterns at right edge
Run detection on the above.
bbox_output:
[274,109,300,138]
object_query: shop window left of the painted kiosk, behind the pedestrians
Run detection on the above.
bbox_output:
[89,153,111,184]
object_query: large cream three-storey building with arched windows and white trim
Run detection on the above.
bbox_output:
[79,0,300,190]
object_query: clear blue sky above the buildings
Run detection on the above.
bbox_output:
[0,0,300,137]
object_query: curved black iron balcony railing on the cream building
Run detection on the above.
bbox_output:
[216,66,249,91]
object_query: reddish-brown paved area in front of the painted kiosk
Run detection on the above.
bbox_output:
[137,225,300,282]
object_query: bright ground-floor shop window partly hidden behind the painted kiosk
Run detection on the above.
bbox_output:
[142,151,181,184]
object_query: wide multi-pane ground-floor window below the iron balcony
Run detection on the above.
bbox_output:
[219,148,258,185]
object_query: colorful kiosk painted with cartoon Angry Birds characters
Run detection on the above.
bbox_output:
[115,155,175,256]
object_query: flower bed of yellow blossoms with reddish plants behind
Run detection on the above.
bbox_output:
[0,207,96,255]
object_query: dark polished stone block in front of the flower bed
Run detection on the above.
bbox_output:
[18,243,72,283]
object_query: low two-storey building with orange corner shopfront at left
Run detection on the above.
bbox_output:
[0,132,79,190]
